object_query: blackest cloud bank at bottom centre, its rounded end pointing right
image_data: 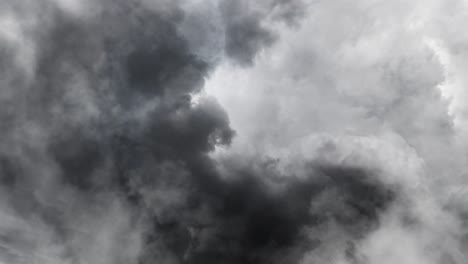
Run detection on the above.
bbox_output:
[131,154,397,263]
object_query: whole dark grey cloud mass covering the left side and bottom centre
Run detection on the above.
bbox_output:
[0,1,404,264]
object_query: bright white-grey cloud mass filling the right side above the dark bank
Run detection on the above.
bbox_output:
[205,0,468,264]
